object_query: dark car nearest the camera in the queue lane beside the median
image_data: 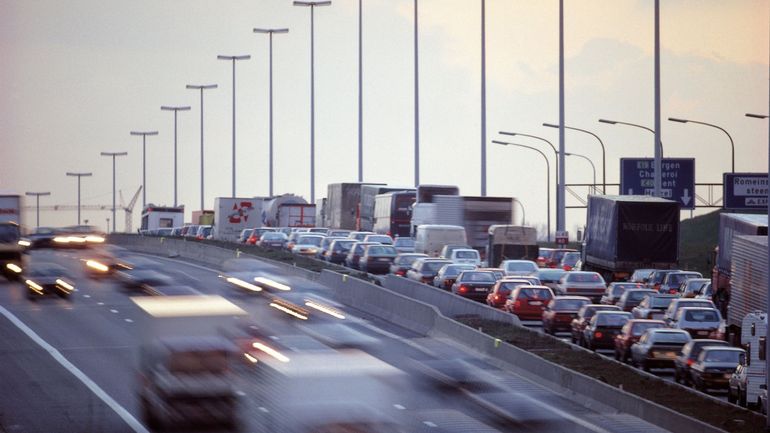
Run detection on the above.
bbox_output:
[690,346,746,392]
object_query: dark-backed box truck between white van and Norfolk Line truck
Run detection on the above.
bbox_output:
[486,224,538,268]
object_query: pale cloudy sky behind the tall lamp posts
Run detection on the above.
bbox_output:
[0,0,770,232]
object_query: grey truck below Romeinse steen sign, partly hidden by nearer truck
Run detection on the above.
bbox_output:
[711,213,767,300]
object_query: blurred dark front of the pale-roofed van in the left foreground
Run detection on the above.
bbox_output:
[139,336,238,429]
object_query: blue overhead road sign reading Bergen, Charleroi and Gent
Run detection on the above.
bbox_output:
[620,158,695,209]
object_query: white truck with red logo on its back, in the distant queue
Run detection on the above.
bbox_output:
[211,197,264,241]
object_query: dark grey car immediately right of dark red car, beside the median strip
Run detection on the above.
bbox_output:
[631,328,691,371]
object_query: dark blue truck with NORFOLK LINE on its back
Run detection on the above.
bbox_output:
[582,195,679,282]
